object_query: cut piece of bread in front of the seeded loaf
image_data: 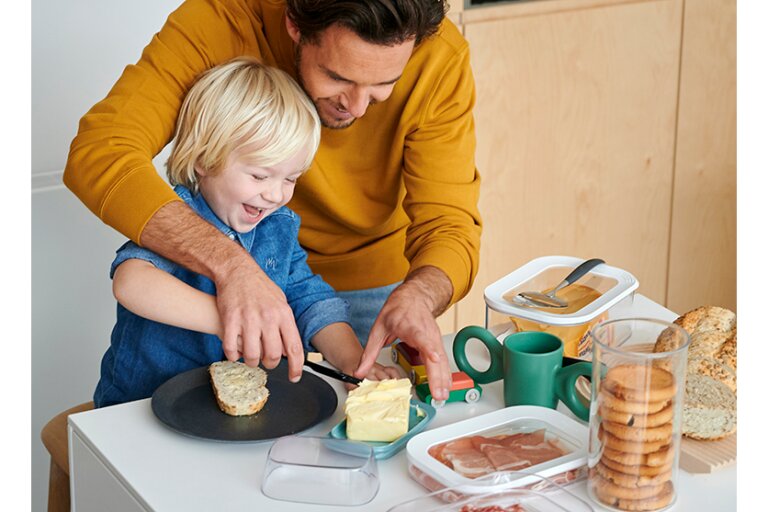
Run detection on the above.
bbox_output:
[683,373,736,441]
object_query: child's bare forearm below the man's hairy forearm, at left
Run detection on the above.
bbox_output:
[112,259,223,337]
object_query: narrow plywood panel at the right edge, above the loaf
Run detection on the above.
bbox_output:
[667,0,736,312]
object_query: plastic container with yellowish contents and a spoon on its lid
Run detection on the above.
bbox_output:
[485,256,639,359]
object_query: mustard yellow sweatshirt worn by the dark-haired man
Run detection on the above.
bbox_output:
[64,0,481,302]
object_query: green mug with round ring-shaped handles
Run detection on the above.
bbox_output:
[453,325,592,421]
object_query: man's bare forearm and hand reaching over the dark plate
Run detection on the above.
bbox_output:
[141,201,304,382]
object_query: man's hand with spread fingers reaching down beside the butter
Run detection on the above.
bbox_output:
[355,267,453,400]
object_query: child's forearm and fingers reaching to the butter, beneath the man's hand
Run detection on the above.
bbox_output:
[312,322,403,380]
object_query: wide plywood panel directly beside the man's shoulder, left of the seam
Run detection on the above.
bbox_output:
[456,0,682,326]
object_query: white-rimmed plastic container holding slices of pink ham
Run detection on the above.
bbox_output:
[406,405,588,494]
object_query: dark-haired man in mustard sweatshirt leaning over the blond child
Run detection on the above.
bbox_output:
[64,0,480,400]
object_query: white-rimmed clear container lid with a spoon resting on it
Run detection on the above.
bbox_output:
[484,256,639,325]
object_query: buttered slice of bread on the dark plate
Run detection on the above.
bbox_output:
[208,361,269,416]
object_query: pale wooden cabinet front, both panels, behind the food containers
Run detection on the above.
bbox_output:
[440,0,735,332]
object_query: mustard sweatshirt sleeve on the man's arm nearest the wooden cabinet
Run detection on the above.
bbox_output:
[403,41,482,303]
